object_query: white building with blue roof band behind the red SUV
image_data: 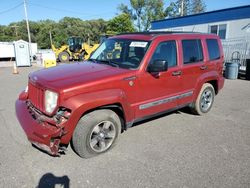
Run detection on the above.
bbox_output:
[151,5,250,39]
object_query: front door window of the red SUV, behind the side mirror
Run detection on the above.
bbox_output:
[150,40,177,68]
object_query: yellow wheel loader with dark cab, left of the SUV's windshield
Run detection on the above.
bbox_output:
[51,37,99,63]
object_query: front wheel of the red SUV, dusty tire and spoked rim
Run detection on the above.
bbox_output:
[72,109,121,158]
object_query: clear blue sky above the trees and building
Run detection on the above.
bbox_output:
[0,0,250,25]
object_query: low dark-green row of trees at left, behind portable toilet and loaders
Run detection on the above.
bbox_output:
[0,17,107,49]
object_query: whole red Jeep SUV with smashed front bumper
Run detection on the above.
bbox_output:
[16,32,224,158]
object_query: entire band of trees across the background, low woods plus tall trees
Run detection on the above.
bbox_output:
[0,0,206,49]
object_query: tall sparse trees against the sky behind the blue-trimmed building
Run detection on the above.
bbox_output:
[118,0,206,31]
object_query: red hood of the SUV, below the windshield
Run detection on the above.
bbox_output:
[29,61,131,91]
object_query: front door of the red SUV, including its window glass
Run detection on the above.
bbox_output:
[136,40,181,119]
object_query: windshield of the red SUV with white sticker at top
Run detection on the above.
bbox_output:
[89,39,150,69]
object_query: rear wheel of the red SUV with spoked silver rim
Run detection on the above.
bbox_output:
[191,83,215,115]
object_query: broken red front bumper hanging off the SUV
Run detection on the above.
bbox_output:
[16,94,67,156]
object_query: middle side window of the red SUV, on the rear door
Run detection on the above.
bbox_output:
[182,39,203,64]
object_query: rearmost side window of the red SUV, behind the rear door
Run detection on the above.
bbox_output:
[206,39,220,60]
